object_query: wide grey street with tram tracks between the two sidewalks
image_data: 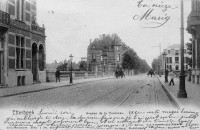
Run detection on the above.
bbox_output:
[0,75,177,110]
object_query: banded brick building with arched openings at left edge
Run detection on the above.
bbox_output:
[0,0,46,87]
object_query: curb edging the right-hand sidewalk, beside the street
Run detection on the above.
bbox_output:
[156,75,181,109]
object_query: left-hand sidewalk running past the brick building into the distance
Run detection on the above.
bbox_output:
[0,76,114,98]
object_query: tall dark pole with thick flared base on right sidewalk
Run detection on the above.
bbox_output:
[177,0,187,98]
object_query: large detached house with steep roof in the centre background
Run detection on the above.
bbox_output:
[87,34,129,73]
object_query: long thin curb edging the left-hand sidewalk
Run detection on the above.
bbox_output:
[0,77,114,98]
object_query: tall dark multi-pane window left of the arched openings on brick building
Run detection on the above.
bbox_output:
[16,36,25,69]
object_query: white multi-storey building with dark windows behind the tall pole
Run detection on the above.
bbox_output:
[163,44,191,71]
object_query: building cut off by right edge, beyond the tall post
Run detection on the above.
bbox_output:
[187,0,200,84]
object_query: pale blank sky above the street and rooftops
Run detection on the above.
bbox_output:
[37,0,191,65]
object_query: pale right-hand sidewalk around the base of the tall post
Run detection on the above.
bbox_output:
[159,75,200,109]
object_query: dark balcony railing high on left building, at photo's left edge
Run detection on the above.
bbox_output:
[0,10,10,28]
